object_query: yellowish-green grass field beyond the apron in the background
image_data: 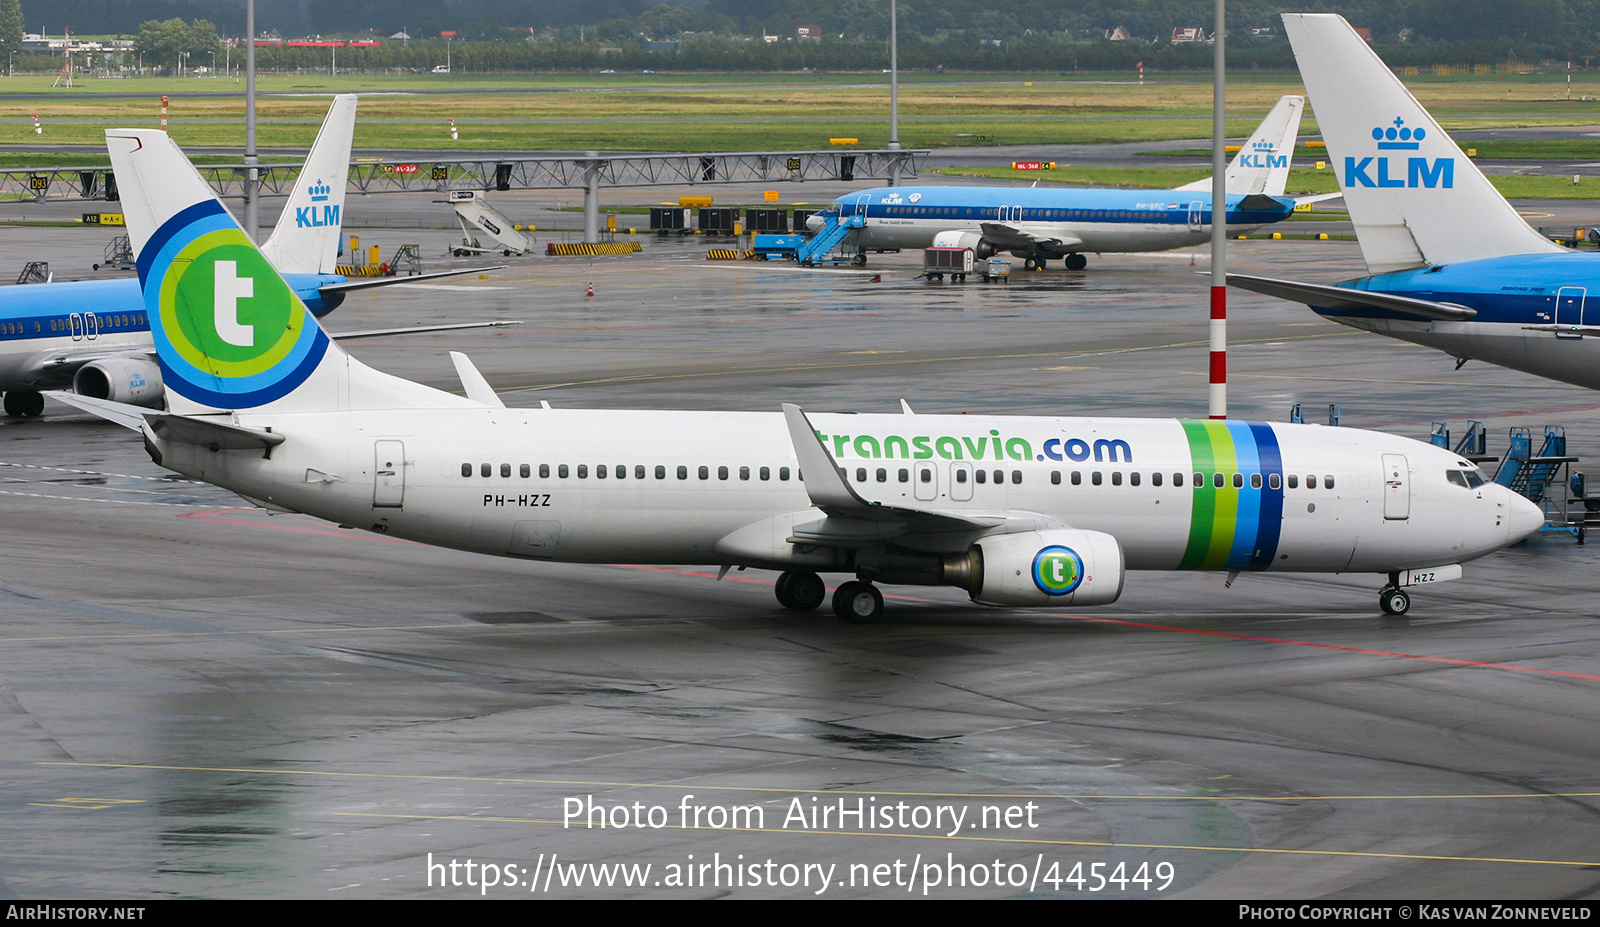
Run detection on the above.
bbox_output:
[0,72,1600,157]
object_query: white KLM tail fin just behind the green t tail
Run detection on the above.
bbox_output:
[261,93,355,274]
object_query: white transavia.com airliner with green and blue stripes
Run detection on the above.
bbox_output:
[59,130,1544,621]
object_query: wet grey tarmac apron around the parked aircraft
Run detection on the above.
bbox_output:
[0,192,1600,898]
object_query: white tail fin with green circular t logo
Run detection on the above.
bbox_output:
[106,128,472,415]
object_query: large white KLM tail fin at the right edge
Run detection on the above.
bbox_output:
[1283,13,1563,274]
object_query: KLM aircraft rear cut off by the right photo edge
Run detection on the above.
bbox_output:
[1227,13,1600,389]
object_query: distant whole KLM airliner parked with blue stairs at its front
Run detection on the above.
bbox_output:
[808,96,1330,271]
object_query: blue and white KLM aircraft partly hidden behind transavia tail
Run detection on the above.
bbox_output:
[0,94,492,416]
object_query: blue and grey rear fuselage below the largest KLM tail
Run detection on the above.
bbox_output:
[1312,251,1600,389]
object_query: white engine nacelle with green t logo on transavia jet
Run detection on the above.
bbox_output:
[941,528,1125,608]
